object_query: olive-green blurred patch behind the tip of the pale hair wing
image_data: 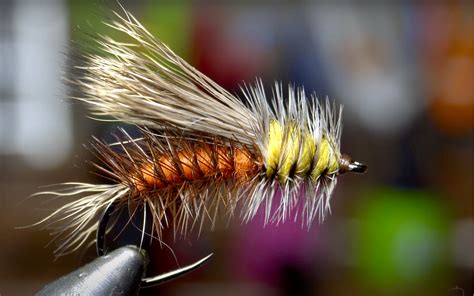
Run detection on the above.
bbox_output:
[68,0,192,58]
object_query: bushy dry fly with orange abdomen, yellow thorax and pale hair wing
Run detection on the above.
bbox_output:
[34,6,366,254]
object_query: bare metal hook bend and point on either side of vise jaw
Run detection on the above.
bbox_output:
[96,201,213,288]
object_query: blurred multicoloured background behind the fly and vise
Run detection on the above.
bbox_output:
[0,0,474,296]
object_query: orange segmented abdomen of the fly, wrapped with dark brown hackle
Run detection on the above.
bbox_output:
[95,131,264,193]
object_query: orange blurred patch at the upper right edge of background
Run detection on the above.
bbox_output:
[424,5,474,134]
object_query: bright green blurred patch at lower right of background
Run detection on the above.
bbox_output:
[356,188,452,295]
